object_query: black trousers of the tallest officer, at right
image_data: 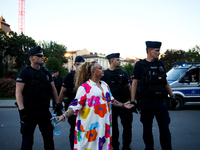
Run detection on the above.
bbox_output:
[140,98,172,150]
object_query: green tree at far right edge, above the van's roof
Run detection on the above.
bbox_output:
[185,45,200,62]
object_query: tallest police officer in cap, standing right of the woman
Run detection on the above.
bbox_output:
[131,41,174,150]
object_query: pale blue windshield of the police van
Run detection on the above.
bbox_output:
[167,68,187,81]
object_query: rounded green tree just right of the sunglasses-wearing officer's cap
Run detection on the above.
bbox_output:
[38,41,68,65]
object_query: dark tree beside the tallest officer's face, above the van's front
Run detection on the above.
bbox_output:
[160,49,186,72]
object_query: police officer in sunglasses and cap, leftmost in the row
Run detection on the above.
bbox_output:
[16,46,58,150]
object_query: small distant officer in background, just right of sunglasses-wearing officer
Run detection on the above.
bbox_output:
[52,70,63,109]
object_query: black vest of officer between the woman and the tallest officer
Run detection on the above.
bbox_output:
[104,69,130,102]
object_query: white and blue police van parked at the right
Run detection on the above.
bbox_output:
[167,62,200,110]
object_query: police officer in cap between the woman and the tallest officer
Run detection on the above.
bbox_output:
[101,53,133,150]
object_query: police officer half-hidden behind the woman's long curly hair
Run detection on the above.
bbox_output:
[59,56,85,150]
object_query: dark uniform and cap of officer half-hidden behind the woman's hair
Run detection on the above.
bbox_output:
[62,56,85,150]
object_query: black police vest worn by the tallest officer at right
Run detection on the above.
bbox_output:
[139,60,167,97]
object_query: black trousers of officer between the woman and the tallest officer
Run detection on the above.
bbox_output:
[112,106,133,149]
